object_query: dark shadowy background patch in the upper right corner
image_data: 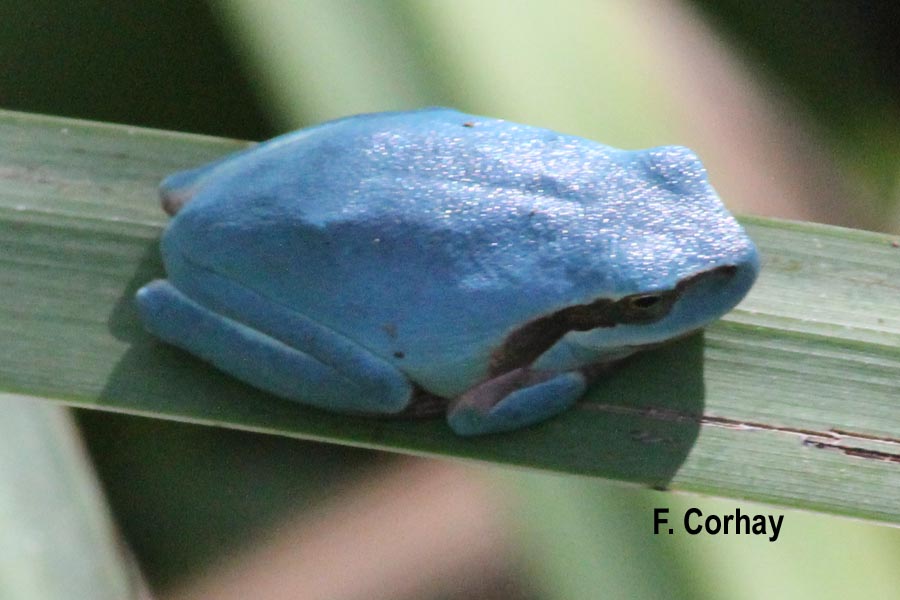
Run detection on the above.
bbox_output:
[692,0,900,116]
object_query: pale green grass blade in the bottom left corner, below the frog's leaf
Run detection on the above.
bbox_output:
[0,394,140,600]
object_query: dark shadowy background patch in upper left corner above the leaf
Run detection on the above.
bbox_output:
[0,0,272,139]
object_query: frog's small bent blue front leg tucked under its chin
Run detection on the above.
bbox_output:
[447,368,587,435]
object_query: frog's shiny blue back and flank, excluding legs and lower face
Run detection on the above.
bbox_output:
[164,109,742,396]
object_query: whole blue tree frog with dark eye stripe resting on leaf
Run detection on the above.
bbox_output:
[137,109,759,435]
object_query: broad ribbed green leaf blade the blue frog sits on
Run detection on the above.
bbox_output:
[0,113,900,523]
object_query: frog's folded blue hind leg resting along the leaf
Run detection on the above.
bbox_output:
[137,280,413,414]
